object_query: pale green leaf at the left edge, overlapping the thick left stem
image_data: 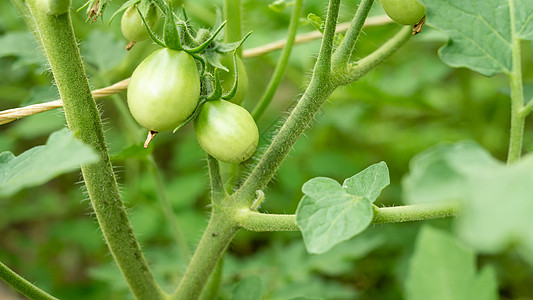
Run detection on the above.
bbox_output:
[0,129,98,197]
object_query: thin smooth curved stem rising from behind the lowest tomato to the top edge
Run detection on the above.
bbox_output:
[252,0,303,121]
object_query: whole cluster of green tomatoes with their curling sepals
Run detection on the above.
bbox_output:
[122,0,259,163]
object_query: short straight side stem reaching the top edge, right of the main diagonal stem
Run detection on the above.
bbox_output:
[333,0,374,70]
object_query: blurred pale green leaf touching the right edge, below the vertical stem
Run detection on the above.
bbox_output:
[457,156,533,252]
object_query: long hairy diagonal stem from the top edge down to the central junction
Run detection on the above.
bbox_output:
[234,0,340,206]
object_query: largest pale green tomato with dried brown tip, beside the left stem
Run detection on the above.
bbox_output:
[128,48,200,132]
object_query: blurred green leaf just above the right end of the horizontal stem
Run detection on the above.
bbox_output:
[402,141,500,204]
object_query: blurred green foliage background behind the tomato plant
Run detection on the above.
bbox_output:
[0,0,533,299]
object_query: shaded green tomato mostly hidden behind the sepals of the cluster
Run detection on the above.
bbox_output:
[220,53,248,104]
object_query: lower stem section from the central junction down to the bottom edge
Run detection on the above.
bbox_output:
[172,210,238,300]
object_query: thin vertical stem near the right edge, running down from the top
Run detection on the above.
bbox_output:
[507,1,525,164]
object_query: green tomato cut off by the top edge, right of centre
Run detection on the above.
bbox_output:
[381,0,426,25]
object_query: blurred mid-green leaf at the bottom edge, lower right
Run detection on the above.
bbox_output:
[405,227,498,300]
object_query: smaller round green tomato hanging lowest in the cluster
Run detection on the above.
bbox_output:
[194,100,259,163]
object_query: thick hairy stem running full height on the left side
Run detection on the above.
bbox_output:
[28,0,164,299]
